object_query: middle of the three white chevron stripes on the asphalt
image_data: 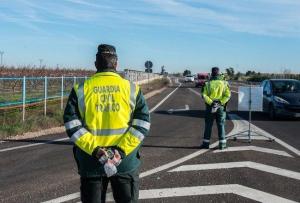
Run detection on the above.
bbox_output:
[169,161,300,180]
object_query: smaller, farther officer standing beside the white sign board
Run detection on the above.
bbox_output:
[201,67,231,149]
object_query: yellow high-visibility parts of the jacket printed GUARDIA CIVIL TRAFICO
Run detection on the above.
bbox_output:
[69,72,145,155]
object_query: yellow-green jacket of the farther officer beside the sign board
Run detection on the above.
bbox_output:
[202,77,231,105]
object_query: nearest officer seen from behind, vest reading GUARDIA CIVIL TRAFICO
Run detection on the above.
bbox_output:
[64,44,150,203]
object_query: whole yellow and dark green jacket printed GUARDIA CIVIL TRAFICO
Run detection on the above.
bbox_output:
[64,71,150,176]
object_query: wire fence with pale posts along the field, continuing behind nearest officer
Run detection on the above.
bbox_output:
[0,70,162,123]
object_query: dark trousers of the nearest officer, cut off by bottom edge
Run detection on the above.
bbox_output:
[80,169,139,203]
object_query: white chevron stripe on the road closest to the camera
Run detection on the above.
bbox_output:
[107,184,295,203]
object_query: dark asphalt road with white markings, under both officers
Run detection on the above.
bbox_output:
[0,81,300,203]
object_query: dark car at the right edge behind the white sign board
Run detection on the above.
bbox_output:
[261,79,300,119]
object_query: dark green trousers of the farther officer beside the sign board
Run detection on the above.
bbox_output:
[203,105,226,147]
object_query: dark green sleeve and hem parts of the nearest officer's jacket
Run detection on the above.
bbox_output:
[64,70,150,177]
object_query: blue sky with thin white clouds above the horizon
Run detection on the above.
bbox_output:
[0,0,300,73]
